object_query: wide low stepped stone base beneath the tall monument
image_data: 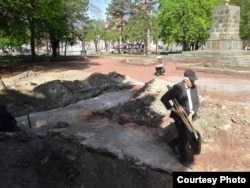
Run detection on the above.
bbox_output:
[166,50,250,75]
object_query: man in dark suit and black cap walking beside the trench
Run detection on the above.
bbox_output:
[161,70,200,167]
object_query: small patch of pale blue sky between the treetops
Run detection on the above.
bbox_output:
[89,0,111,19]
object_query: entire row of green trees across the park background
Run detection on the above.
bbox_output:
[0,0,250,58]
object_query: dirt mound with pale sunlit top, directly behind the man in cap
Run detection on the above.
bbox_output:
[108,79,171,127]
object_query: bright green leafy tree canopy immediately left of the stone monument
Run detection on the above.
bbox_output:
[157,0,220,51]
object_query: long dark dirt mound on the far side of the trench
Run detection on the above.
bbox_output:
[33,72,125,109]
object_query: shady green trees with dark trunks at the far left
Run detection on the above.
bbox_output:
[0,0,88,58]
